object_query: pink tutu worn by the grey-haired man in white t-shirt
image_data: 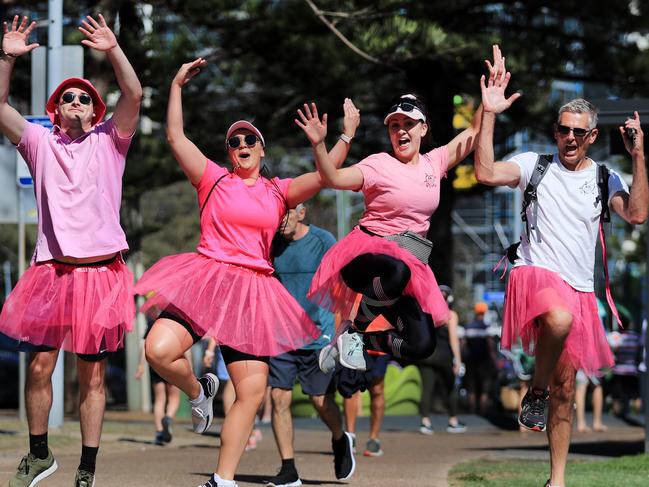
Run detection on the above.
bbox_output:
[502,266,614,375]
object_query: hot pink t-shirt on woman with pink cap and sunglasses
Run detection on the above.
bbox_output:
[196,160,292,274]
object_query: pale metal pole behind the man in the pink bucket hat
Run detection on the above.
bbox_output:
[47,0,65,428]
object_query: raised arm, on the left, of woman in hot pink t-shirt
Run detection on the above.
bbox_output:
[167,58,207,185]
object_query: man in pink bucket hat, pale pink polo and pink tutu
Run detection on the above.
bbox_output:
[0,15,142,487]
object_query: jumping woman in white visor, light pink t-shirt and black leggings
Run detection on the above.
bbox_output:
[296,46,502,370]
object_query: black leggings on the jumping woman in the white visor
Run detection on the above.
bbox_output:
[340,254,435,360]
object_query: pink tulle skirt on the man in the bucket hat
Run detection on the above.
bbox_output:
[0,256,135,354]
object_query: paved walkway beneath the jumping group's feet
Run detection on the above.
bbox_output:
[0,412,644,487]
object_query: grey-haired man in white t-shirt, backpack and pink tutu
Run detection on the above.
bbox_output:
[475,67,649,487]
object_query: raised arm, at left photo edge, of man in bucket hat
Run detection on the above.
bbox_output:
[0,15,38,144]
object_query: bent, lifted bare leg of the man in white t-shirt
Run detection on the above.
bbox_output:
[532,308,572,390]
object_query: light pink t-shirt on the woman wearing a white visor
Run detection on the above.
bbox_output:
[356,146,448,236]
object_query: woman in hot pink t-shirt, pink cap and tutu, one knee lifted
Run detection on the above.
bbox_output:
[135,58,360,487]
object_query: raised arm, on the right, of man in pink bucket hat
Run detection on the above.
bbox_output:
[79,14,142,137]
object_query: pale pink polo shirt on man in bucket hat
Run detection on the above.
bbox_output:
[17,119,132,262]
